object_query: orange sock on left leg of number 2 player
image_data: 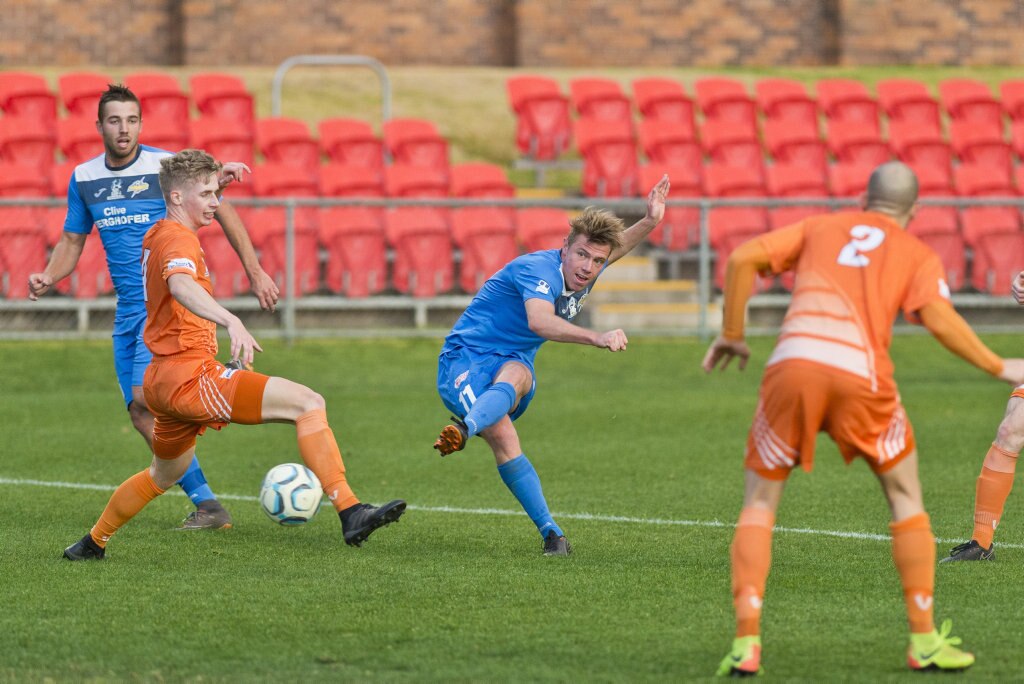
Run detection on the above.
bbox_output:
[730,507,775,637]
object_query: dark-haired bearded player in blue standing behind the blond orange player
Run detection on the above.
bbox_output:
[29,85,279,529]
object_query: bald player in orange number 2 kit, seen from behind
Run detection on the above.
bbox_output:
[703,162,1024,675]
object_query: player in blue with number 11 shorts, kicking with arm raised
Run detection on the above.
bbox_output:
[434,176,669,556]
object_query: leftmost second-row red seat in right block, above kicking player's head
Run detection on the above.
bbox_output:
[575,119,637,197]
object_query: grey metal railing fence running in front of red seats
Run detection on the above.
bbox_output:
[0,197,1024,340]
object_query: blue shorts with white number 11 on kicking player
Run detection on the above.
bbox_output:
[437,347,537,420]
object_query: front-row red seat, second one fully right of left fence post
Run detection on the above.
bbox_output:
[386,207,455,297]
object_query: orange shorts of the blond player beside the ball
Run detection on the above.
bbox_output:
[142,352,270,459]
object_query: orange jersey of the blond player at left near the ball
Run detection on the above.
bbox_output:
[142,218,217,356]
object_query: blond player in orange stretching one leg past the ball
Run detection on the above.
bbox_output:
[63,149,406,560]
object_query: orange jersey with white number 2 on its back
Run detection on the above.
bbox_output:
[759,212,949,391]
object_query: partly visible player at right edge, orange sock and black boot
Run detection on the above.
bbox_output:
[939,271,1024,563]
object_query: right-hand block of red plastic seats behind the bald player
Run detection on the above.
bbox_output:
[507,76,1024,294]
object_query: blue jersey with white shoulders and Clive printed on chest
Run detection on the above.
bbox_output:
[65,145,171,317]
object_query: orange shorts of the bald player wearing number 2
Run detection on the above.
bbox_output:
[745,360,914,480]
